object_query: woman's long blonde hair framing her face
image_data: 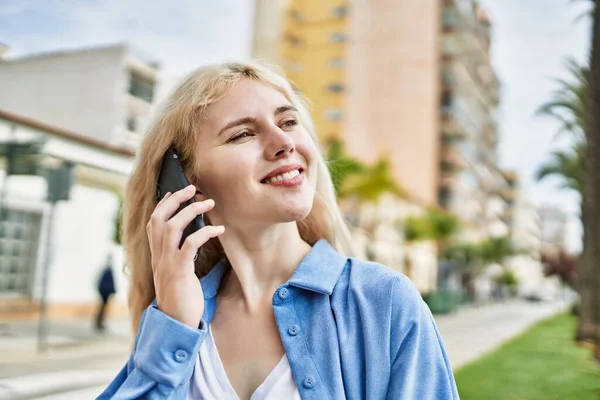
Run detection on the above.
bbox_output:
[123,62,352,331]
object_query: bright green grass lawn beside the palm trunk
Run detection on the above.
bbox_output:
[455,315,600,400]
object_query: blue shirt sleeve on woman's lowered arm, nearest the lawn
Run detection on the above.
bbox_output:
[386,277,459,400]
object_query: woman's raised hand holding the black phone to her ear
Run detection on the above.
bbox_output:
[146,185,225,329]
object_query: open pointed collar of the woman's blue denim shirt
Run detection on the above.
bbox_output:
[200,239,348,299]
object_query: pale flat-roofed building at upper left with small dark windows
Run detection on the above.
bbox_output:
[0,45,158,149]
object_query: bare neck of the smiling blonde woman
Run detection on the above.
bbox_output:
[220,222,311,312]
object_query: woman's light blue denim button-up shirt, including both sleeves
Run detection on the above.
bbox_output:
[98,240,459,400]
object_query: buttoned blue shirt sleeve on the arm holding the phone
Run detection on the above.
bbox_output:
[97,304,208,400]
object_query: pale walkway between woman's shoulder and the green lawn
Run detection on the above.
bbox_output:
[435,300,568,370]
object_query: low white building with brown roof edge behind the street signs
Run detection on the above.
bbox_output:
[0,110,133,318]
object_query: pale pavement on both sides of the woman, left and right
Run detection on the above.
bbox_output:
[0,300,566,400]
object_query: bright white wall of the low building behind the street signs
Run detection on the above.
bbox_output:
[6,176,128,304]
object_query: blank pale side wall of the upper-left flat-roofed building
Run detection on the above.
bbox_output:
[0,47,125,141]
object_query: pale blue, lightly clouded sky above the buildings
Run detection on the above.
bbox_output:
[0,0,590,251]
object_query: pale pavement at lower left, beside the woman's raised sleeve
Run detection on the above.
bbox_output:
[0,319,132,400]
